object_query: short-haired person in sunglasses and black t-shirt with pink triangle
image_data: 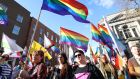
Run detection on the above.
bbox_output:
[73,50,104,79]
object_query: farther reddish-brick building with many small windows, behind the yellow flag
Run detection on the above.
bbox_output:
[27,17,59,65]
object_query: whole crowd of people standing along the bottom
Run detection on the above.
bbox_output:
[0,44,140,79]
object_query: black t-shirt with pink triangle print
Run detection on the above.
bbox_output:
[74,64,104,79]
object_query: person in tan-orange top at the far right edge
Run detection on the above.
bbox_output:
[128,43,140,79]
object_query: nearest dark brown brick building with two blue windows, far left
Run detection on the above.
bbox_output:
[0,0,30,48]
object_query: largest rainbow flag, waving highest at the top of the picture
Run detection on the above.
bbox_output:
[41,0,90,23]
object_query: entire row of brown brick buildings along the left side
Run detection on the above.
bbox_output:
[0,0,76,65]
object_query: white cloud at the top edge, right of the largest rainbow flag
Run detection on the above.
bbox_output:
[94,0,115,8]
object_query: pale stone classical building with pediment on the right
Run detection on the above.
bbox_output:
[99,9,140,57]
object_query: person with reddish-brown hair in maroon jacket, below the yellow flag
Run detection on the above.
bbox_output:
[29,50,47,79]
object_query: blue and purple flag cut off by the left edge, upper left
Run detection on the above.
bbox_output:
[0,7,8,25]
